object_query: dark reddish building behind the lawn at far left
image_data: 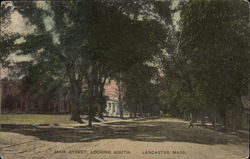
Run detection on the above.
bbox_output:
[1,79,70,113]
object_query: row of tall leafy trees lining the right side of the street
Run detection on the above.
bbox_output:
[161,0,250,130]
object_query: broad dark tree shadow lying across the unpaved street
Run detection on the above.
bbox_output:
[1,120,247,145]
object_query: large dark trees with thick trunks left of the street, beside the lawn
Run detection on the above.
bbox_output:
[0,0,172,125]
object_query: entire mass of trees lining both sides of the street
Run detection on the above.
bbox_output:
[1,0,250,129]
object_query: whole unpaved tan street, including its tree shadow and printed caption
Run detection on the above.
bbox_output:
[0,119,249,159]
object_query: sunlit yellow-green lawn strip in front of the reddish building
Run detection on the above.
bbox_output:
[0,114,76,124]
